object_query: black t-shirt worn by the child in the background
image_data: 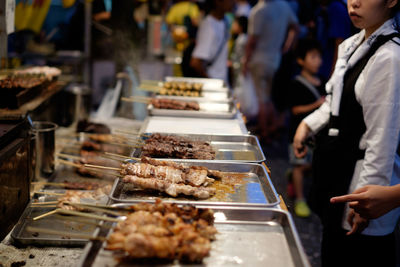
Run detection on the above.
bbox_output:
[288,75,326,142]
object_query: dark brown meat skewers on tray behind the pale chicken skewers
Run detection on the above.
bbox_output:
[142,134,215,160]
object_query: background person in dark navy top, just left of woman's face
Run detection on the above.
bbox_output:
[315,0,352,80]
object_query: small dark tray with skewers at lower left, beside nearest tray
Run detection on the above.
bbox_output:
[11,182,111,246]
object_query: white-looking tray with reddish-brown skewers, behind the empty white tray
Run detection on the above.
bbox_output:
[122,96,237,119]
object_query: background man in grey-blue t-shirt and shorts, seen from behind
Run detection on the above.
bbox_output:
[243,0,298,143]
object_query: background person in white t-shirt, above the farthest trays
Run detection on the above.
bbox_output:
[190,0,234,82]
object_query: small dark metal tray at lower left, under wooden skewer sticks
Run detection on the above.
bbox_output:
[11,190,108,247]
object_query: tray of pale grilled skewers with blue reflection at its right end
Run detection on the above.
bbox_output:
[107,157,280,207]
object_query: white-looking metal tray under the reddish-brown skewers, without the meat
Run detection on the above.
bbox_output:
[147,101,238,119]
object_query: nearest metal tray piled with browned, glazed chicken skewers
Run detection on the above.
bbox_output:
[80,201,310,267]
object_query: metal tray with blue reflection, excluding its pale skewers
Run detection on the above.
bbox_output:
[110,160,280,207]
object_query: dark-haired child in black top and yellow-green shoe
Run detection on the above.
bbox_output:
[289,39,325,217]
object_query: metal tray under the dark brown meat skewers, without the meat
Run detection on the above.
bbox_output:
[132,133,265,163]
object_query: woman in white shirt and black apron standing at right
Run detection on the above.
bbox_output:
[293,0,400,266]
